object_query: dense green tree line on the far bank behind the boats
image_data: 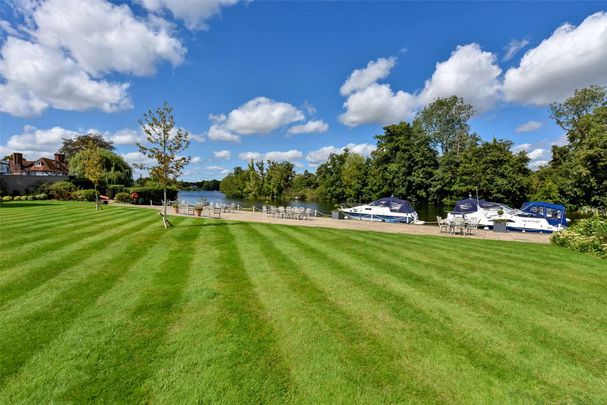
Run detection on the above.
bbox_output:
[220,86,607,209]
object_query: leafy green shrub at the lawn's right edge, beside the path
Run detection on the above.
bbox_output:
[550,214,607,258]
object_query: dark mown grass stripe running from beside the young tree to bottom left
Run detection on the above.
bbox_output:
[62,221,202,403]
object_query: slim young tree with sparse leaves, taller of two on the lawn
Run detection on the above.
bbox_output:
[137,102,191,228]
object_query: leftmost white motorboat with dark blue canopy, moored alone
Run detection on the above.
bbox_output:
[339,197,423,224]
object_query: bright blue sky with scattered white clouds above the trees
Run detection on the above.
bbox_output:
[0,0,607,180]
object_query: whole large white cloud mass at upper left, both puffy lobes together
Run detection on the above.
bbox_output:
[0,0,186,117]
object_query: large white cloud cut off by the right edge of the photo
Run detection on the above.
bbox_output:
[504,12,607,106]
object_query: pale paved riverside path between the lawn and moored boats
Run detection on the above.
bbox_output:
[113,204,550,243]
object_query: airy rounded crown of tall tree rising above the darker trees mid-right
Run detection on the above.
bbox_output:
[415,96,474,155]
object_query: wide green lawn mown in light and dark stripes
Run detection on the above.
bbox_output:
[0,201,607,404]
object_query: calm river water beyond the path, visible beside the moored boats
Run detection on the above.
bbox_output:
[178,191,448,222]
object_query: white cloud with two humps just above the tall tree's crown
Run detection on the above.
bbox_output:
[339,43,501,126]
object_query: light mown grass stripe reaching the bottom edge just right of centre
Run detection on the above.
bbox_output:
[239,224,440,402]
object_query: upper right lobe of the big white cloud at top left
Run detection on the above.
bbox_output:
[33,0,186,76]
